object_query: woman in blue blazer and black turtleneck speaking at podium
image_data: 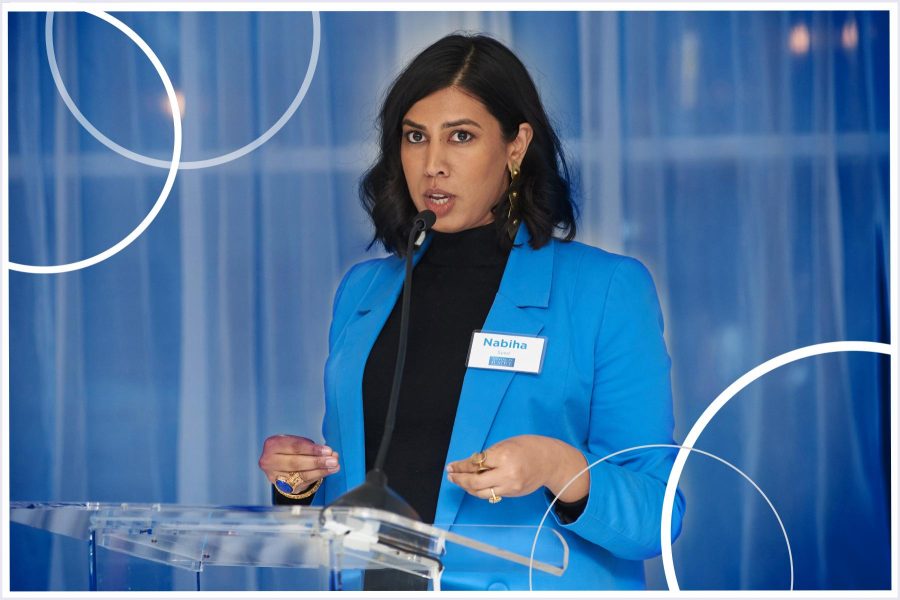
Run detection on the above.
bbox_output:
[260,35,684,589]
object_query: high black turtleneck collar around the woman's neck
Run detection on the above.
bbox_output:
[422,223,511,267]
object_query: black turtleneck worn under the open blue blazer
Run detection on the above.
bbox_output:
[363,225,509,523]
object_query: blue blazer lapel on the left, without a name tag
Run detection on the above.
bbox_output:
[334,236,431,490]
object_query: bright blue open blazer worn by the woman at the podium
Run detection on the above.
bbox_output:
[316,227,684,590]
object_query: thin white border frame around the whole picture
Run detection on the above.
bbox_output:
[0,0,900,599]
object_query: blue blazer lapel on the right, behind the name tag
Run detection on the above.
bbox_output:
[434,227,556,525]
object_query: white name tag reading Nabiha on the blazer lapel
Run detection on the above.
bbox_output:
[467,331,547,373]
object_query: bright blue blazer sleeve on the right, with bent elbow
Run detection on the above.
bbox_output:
[551,257,685,560]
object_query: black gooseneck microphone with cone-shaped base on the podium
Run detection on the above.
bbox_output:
[328,210,437,521]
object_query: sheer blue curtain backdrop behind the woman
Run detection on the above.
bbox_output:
[6,12,890,590]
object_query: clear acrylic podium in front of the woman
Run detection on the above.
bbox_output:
[10,502,568,590]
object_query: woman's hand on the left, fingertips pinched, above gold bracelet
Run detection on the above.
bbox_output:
[259,435,341,493]
